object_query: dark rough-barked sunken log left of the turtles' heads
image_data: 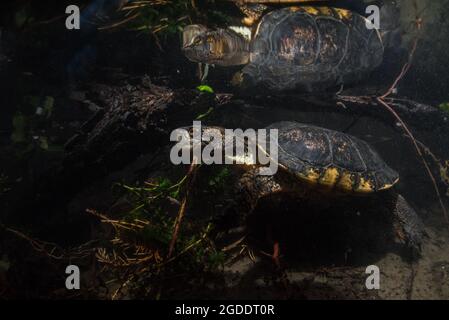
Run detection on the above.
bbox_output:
[63,80,214,180]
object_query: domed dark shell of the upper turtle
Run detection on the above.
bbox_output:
[242,7,384,90]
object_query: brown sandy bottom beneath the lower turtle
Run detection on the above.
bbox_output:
[211,204,449,300]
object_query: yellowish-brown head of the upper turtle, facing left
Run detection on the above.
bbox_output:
[182,25,249,66]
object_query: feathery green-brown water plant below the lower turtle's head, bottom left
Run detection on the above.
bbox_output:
[95,177,225,299]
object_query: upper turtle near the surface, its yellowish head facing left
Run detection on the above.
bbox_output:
[182,1,396,92]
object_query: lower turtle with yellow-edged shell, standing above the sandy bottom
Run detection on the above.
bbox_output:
[177,121,426,264]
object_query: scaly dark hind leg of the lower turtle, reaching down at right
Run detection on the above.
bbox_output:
[393,194,426,256]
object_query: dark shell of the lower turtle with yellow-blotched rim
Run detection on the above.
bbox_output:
[267,122,399,193]
